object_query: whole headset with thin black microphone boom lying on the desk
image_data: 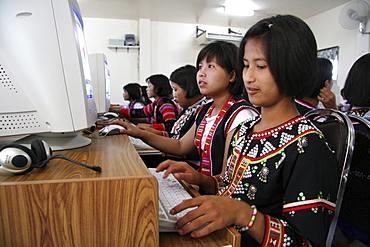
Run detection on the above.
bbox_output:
[0,140,101,174]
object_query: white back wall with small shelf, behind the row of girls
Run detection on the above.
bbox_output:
[83,18,243,104]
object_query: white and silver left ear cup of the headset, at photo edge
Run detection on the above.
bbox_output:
[0,144,36,174]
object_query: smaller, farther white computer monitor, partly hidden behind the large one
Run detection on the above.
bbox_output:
[89,53,110,115]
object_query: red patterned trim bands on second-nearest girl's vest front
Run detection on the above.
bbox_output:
[194,95,235,176]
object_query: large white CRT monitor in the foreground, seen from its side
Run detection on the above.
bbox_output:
[0,0,97,150]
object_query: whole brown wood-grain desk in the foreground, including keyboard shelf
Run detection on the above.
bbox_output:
[0,135,240,247]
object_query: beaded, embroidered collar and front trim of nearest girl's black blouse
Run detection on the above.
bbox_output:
[218,116,321,200]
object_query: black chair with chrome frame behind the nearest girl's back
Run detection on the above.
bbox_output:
[305,109,355,247]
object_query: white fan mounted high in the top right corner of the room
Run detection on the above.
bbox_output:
[339,0,370,34]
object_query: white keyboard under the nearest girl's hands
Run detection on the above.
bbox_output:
[148,168,195,232]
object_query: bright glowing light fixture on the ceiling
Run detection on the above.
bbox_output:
[223,0,258,16]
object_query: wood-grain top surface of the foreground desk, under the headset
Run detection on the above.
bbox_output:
[0,135,151,182]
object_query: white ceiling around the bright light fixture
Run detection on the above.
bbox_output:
[77,0,350,28]
